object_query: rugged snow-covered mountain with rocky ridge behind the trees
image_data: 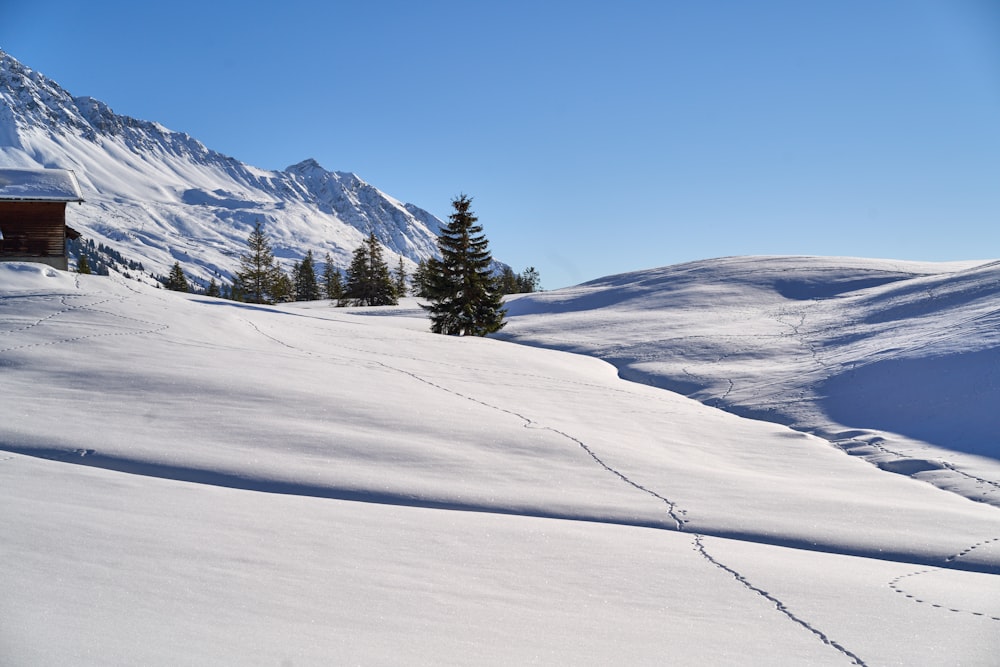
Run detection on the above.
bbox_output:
[0,51,440,281]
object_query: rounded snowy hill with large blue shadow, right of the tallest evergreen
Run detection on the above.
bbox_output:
[503,257,1000,506]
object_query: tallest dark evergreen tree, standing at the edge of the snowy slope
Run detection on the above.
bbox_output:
[423,195,507,336]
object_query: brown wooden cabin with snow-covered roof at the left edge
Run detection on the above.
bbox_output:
[0,169,83,271]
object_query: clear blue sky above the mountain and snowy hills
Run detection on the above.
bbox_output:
[0,0,1000,288]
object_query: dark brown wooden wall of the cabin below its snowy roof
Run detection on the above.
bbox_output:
[0,201,66,259]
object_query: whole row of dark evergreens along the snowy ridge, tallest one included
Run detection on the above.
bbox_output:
[164,195,539,336]
